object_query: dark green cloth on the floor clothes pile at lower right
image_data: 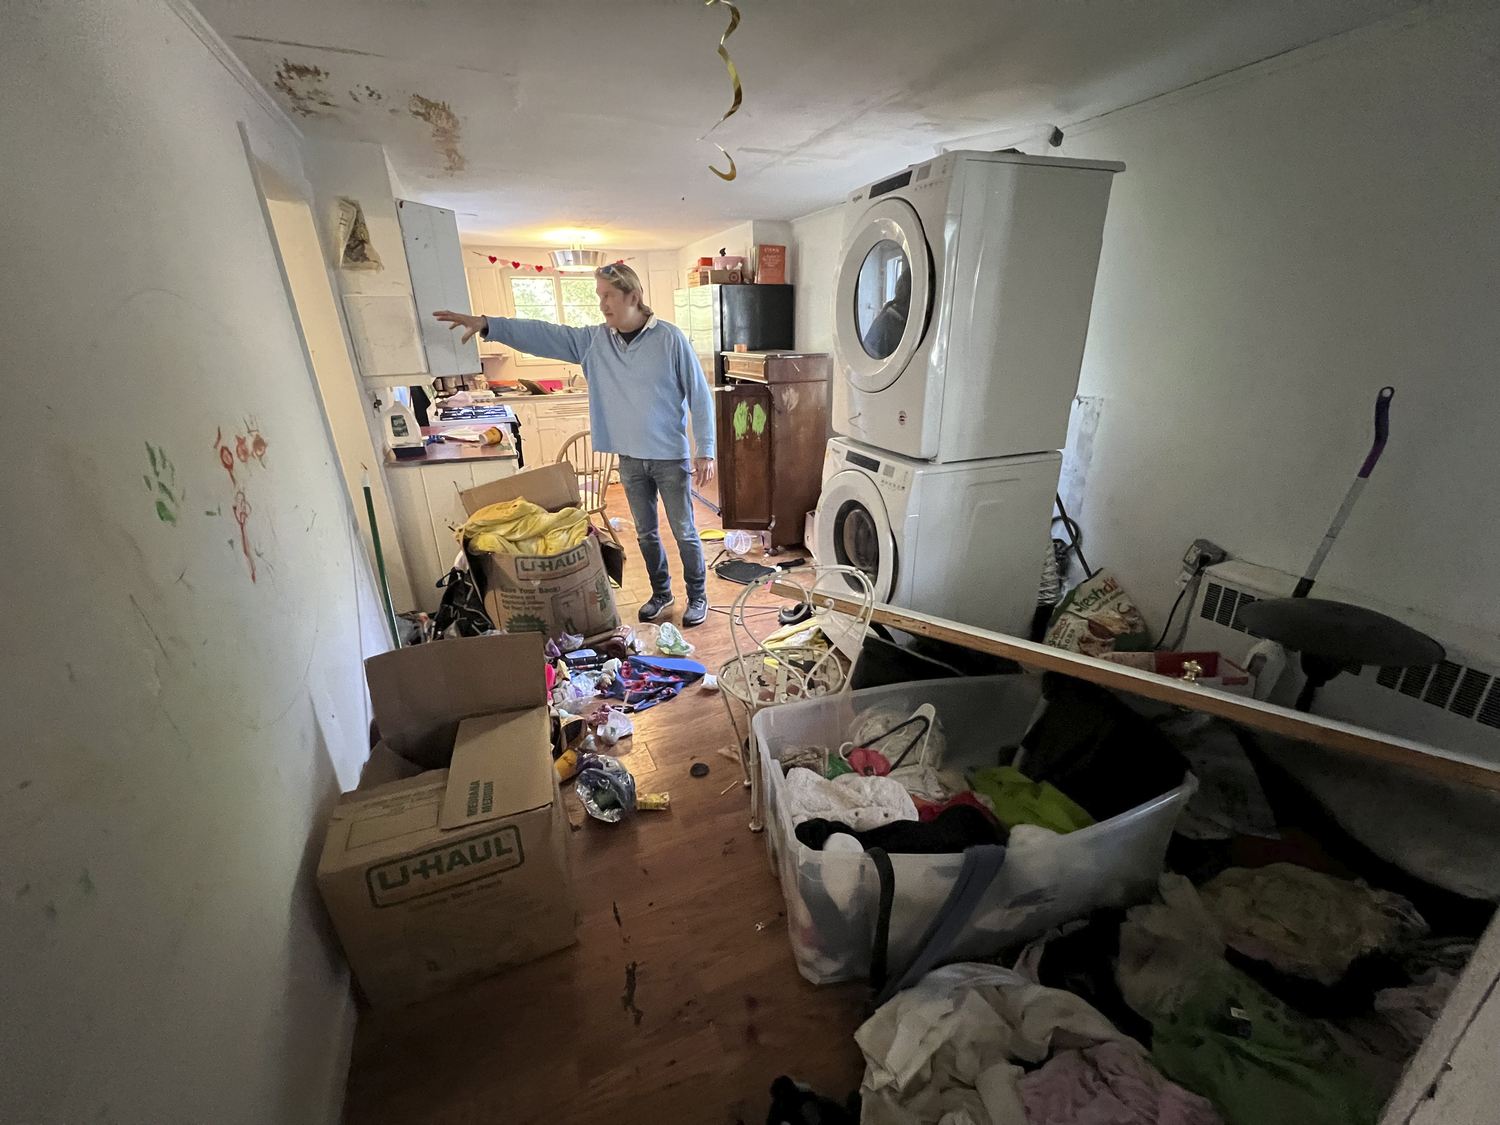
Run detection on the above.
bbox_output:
[1151,962,1385,1125]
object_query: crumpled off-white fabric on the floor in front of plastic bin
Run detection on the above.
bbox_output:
[854,963,1142,1125]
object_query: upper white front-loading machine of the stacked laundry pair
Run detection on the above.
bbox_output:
[834,152,1125,461]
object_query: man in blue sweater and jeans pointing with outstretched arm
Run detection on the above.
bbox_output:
[432,264,714,626]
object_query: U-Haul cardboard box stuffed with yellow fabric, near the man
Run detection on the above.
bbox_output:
[459,462,620,638]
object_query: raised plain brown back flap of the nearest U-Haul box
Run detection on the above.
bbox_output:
[365,633,548,765]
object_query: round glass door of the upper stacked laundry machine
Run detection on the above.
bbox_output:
[834,200,932,392]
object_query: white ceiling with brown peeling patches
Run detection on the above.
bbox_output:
[197,0,1418,248]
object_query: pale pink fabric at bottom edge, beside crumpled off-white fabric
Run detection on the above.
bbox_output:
[1016,1043,1223,1125]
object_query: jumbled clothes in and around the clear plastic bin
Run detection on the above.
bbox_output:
[783,678,1491,1125]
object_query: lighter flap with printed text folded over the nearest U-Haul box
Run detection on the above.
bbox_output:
[438,707,555,828]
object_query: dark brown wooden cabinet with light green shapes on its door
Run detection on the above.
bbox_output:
[714,353,831,548]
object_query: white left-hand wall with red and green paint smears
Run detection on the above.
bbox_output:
[0,0,384,1125]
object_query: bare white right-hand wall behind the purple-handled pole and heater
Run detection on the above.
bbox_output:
[1062,6,1500,642]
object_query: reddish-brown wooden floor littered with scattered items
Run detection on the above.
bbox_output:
[345,486,866,1125]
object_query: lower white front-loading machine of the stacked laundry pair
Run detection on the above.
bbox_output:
[813,438,1062,636]
